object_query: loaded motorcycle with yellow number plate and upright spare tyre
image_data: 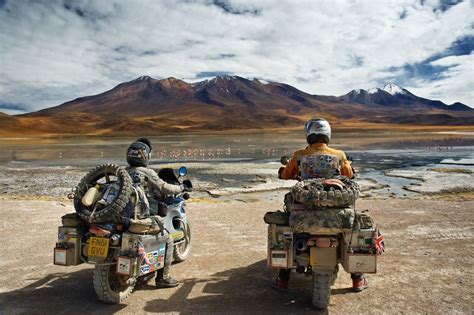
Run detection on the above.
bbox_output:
[54,164,192,303]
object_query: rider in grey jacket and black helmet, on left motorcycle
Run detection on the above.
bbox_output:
[127,138,183,288]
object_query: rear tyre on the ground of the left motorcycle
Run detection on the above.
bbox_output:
[93,265,136,304]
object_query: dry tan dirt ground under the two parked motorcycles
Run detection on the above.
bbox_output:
[0,196,474,314]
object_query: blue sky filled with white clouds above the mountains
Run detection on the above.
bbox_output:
[0,0,474,114]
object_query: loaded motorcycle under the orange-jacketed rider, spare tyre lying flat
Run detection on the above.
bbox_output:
[264,156,384,309]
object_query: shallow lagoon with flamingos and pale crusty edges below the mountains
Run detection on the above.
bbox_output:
[0,132,474,197]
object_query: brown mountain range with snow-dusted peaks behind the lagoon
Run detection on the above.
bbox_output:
[0,76,474,135]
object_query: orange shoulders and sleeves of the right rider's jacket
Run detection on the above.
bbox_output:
[279,143,354,179]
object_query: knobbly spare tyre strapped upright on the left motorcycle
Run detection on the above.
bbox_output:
[74,164,133,223]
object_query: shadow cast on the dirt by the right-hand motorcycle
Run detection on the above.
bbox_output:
[144,260,336,314]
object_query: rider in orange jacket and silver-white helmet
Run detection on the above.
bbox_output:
[275,118,369,292]
